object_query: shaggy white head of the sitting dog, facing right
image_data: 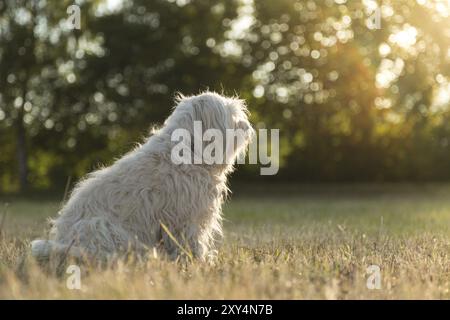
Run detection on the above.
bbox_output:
[165,92,254,169]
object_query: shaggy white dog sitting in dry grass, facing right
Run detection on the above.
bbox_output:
[31,92,253,259]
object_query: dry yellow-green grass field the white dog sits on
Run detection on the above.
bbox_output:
[0,185,450,299]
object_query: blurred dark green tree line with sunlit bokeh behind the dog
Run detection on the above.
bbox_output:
[0,0,450,192]
